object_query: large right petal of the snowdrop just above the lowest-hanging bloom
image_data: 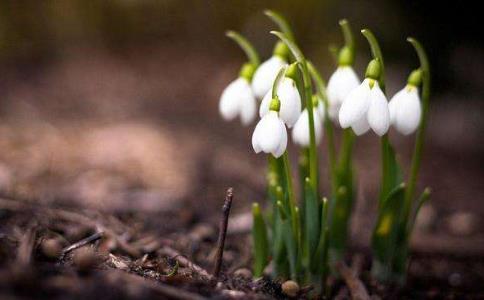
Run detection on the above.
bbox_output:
[277,77,301,128]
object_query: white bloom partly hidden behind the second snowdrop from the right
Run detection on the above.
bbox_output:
[327,66,360,120]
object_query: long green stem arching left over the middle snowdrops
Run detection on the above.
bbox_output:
[271,31,318,195]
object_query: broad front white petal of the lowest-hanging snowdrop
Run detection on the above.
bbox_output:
[257,111,282,153]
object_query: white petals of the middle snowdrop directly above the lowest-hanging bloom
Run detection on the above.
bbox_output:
[259,77,301,128]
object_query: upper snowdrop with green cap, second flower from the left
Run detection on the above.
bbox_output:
[252,42,289,99]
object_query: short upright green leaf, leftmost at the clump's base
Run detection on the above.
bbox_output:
[252,203,269,277]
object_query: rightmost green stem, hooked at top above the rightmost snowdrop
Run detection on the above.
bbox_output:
[404,38,430,219]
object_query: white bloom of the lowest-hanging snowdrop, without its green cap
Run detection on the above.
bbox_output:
[252,110,287,158]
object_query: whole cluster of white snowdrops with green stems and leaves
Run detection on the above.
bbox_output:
[219,11,430,291]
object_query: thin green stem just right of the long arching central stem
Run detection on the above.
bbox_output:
[307,61,337,189]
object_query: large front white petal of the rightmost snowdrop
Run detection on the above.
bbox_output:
[395,88,422,135]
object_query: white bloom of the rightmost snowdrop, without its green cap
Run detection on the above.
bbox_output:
[388,85,422,135]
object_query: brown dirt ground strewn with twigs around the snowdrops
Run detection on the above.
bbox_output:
[0,45,484,299]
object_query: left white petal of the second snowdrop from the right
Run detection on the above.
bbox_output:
[339,79,370,128]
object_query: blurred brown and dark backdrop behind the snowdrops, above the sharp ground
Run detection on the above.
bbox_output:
[0,0,484,236]
